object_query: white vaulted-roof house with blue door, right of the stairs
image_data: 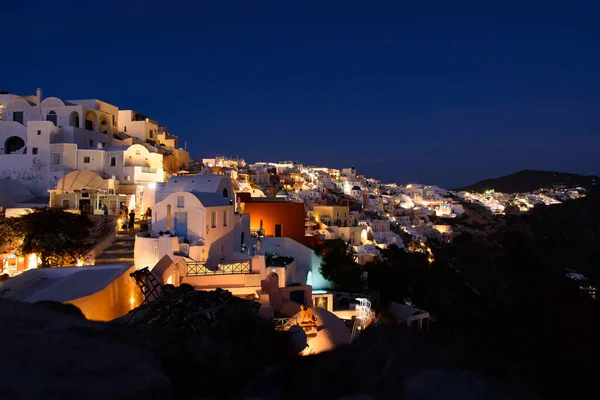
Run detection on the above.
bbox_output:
[134,175,250,268]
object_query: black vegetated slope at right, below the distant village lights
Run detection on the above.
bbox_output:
[322,189,600,398]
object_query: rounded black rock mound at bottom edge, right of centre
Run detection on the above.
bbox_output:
[241,326,535,399]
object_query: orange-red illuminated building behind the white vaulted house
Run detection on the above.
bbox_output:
[238,193,305,244]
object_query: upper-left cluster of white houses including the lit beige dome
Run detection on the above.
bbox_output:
[0,89,189,213]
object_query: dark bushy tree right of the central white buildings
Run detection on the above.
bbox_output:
[315,239,365,292]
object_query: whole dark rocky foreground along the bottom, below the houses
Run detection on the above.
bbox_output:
[0,292,530,399]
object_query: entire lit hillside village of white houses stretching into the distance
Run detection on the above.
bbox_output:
[0,89,585,352]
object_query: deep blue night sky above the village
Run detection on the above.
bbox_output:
[0,0,600,187]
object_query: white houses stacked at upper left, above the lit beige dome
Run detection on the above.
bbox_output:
[0,89,189,199]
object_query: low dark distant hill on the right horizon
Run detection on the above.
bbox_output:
[453,169,600,193]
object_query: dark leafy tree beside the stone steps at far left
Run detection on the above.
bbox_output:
[0,208,93,268]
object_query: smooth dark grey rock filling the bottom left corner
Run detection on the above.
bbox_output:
[0,299,173,400]
